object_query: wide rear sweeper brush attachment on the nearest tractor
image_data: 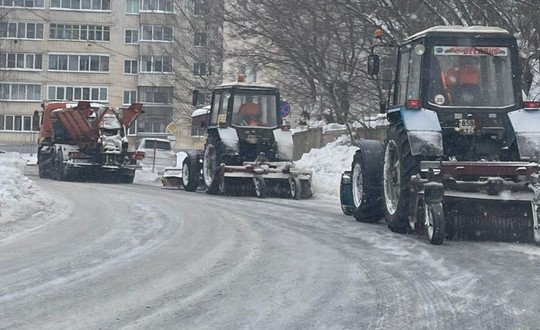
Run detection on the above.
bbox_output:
[411,161,540,245]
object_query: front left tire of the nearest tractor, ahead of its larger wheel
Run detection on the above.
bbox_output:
[351,140,384,223]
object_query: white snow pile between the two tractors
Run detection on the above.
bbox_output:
[295,135,358,200]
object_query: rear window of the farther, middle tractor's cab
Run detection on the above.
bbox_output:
[232,94,277,128]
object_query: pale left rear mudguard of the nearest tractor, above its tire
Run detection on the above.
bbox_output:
[400,108,444,156]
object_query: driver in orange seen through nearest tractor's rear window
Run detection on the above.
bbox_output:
[441,56,480,105]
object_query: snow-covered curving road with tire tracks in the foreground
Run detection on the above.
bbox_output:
[0,178,540,329]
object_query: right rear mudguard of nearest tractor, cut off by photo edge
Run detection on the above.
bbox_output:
[508,109,540,162]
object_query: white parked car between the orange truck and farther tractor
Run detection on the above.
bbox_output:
[137,138,176,173]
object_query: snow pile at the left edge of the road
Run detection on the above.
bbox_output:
[0,153,54,224]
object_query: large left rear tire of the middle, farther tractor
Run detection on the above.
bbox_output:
[203,134,223,195]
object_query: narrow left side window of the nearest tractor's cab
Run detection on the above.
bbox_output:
[396,44,423,105]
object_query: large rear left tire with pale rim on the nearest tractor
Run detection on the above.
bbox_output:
[383,123,420,233]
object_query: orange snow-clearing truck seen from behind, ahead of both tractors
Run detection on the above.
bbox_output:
[38,101,144,183]
